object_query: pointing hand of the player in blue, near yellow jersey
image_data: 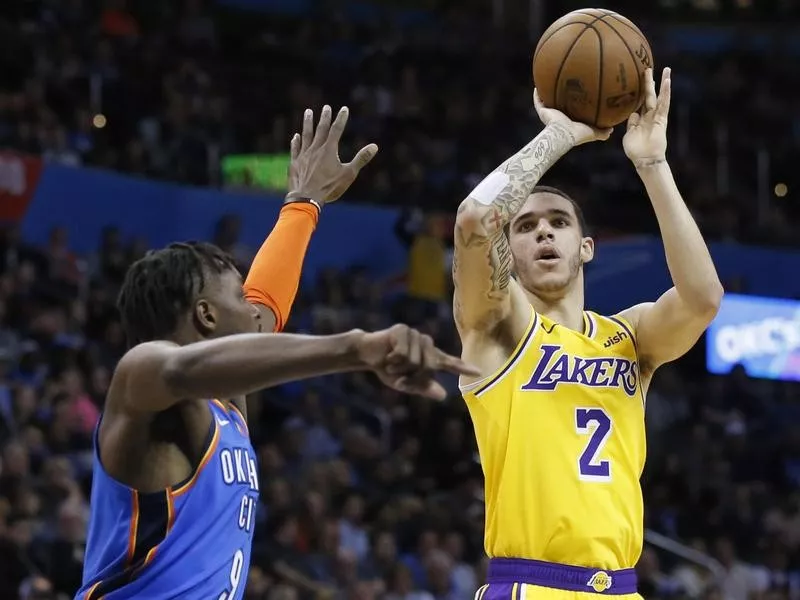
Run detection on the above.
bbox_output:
[359,325,480,400]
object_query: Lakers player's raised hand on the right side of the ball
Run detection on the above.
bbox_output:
[622,67,672,166]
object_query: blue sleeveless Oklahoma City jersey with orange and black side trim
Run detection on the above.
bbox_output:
[75,400,258,600]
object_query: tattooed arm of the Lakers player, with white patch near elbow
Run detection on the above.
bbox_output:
[453,95,611,352]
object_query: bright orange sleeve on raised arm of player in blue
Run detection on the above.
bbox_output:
[244,202,319,331]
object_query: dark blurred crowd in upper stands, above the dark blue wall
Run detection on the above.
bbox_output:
[0,0,800,245]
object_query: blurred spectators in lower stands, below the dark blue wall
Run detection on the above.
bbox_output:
[0,217,800,600]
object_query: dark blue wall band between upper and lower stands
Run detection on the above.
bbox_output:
[14,164,800,314]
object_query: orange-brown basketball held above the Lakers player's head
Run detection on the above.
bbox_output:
[533,8,653,128]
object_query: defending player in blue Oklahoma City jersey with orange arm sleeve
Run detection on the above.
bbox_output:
[76,106,477,600]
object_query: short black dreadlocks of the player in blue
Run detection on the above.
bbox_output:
[117,242,236,346]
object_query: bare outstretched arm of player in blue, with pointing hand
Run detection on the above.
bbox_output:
[108,325,475,414]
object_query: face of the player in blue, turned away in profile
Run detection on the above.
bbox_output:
[195,269,260,338]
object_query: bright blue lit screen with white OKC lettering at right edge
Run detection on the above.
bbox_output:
[706,294,800,381]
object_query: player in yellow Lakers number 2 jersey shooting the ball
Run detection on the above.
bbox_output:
[453,69,722,600]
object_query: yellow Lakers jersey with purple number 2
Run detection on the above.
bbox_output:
[462,312,646,570]
